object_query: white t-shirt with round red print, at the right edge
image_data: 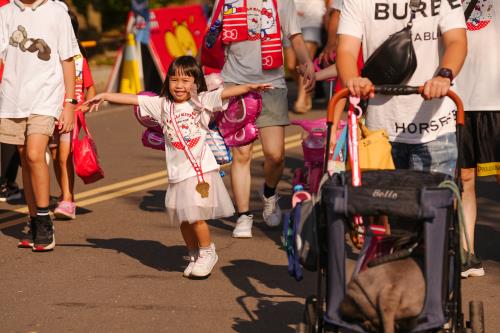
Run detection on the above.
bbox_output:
[457,0,500,111]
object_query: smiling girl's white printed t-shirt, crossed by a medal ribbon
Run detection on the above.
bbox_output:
[138,89,227,183]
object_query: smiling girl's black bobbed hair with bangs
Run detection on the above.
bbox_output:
[160,56,207,101]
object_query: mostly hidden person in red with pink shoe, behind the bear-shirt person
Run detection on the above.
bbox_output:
[49,11,96,220]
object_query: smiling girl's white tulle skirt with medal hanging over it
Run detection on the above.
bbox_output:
[165,171,234,224]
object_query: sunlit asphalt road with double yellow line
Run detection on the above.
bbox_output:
[0,102,500,333]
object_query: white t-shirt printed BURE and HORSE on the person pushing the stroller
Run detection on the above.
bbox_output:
[338,0,465,144]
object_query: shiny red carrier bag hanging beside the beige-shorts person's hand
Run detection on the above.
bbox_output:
[73,111,104,184]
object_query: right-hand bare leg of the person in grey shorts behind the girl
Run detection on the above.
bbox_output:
[260,126,285,188]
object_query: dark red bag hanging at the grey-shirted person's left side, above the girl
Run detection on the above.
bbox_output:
[201,0,225,72]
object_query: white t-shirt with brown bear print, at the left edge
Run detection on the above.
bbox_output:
[0,1,80,118]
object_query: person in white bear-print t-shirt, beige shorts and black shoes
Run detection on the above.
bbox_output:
[0,0,80,251]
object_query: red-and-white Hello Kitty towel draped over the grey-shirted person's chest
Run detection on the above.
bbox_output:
[221,0,283,70]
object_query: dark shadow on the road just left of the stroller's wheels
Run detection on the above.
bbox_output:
[222,260,314,333]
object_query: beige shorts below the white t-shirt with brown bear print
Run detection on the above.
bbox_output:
[0,114,55,146]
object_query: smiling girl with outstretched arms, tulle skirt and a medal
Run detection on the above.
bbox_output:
[83,56,271,277]
